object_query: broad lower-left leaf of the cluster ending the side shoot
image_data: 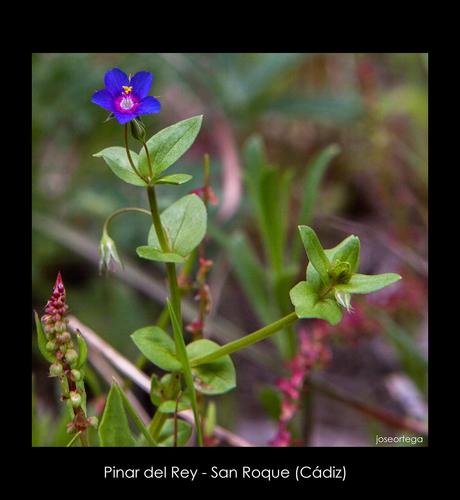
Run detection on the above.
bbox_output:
[289,281,342,325]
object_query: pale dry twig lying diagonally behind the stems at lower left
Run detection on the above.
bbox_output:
[68,316,254,447]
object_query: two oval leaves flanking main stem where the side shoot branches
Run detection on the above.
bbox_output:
[131,326,236,395]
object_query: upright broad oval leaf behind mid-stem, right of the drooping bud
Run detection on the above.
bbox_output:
[148,194,207,257]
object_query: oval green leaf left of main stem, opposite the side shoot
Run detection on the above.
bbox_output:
[131,326,182,371]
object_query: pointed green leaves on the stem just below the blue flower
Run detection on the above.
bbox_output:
[93,115,203,186]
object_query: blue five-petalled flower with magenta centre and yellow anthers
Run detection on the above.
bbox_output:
[91,68,161,124]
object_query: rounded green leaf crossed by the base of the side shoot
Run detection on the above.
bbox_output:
[187,339,236,395]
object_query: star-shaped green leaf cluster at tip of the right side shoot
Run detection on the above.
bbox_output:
[290,226,401,325]
